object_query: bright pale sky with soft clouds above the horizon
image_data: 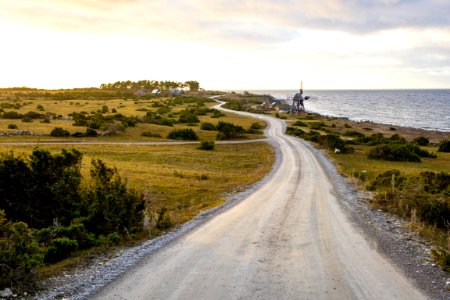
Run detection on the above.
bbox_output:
[0,0,450,90]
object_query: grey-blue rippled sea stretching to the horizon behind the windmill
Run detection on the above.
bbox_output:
[249,89,450,132]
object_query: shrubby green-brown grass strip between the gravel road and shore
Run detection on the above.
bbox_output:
[286,114,450,271]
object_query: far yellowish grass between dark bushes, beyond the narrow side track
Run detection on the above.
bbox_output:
[0,92,264,142]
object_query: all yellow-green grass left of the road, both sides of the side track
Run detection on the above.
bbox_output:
[0,91,274,230]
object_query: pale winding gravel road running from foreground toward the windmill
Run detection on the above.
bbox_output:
[95,106,425,299]
